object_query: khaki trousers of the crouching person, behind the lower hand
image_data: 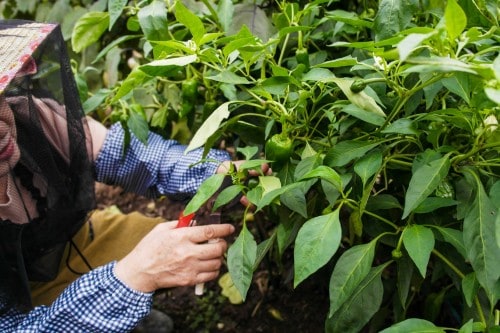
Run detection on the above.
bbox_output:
[31,210,164,306]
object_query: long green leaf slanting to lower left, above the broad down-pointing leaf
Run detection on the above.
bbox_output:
[401,155,450,219]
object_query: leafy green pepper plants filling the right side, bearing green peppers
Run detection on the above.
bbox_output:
[72,0,500,333]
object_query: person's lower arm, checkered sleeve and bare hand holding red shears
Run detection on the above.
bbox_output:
[0,221,234,333]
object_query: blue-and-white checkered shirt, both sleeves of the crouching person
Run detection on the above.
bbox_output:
[0,124,230,333]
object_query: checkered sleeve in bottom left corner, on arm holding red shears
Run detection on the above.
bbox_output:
[0,262,153,333]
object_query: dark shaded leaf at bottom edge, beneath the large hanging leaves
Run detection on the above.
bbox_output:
[325,263,389,333]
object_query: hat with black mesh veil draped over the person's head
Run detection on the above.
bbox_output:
[0,20,95,313]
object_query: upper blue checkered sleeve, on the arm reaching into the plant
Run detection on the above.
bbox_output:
[95,123,230,199]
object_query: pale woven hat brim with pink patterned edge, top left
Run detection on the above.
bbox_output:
[0,20,57,94]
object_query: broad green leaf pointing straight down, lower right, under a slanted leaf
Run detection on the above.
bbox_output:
[402,224,434,279]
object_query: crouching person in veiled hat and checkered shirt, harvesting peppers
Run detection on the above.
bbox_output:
[0,20,265,332]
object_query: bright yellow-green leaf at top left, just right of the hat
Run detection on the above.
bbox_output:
[71,12,109,53]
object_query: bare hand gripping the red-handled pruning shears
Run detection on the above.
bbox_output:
[115,221,234,292]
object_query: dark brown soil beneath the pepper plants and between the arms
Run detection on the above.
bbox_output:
[96,184,329,333]
